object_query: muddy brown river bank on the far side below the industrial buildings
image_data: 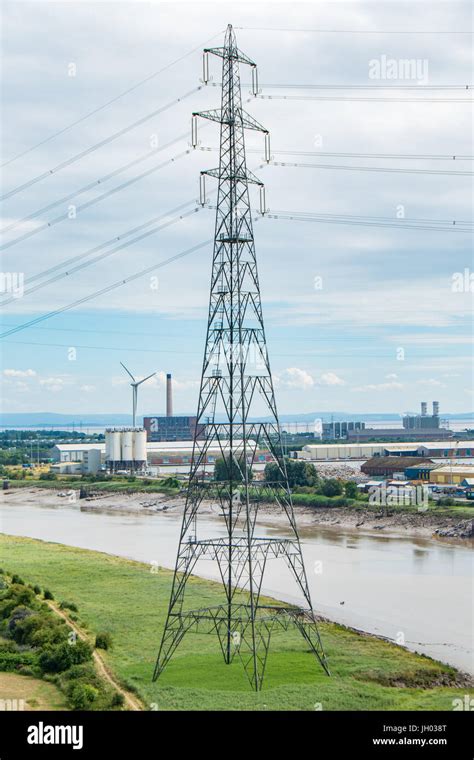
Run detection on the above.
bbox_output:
[1,488,474,545]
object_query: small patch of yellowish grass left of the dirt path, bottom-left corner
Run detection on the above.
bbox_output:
[0,673,67,710]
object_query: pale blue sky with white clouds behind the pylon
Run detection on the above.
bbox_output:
[0,0,474,416]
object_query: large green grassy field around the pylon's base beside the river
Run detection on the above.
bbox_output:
[0,535,474,710]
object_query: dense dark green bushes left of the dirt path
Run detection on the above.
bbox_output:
[0,574,120,710]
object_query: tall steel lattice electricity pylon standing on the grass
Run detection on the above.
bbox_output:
[153,25,329,690]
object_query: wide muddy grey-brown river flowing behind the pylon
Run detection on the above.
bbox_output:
[0,502,474,673]
